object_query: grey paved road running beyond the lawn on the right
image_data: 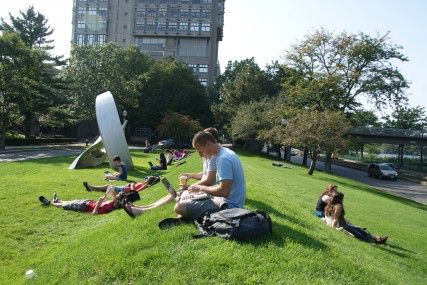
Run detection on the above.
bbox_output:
[291,156,427,205]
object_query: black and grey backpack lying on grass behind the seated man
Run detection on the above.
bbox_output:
[193,208,272,241]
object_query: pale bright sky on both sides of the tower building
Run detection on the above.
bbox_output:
[0,0,427,112]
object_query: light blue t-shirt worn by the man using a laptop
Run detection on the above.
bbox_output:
[216,147,246,208]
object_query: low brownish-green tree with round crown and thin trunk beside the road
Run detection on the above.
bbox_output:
[280,111,350,175]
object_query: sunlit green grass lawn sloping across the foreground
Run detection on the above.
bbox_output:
[0,148,427,284]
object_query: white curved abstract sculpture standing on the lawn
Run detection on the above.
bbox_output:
[69,91,133,169]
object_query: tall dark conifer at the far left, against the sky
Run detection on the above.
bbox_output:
[0,6,67,138]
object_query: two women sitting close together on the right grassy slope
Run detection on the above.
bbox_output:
[314,185,387,244]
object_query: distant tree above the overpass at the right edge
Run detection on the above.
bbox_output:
[383,106,427,130]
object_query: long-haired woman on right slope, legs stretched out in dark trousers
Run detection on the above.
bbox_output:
[325,192,388,244]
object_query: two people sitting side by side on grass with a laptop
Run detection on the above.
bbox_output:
[124,128,246,219]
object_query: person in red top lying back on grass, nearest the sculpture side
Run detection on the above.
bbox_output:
[39,187,120,215]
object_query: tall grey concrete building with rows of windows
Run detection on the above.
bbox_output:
[72,0,225,86]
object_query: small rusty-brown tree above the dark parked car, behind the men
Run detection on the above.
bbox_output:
[157,112,202,142]
